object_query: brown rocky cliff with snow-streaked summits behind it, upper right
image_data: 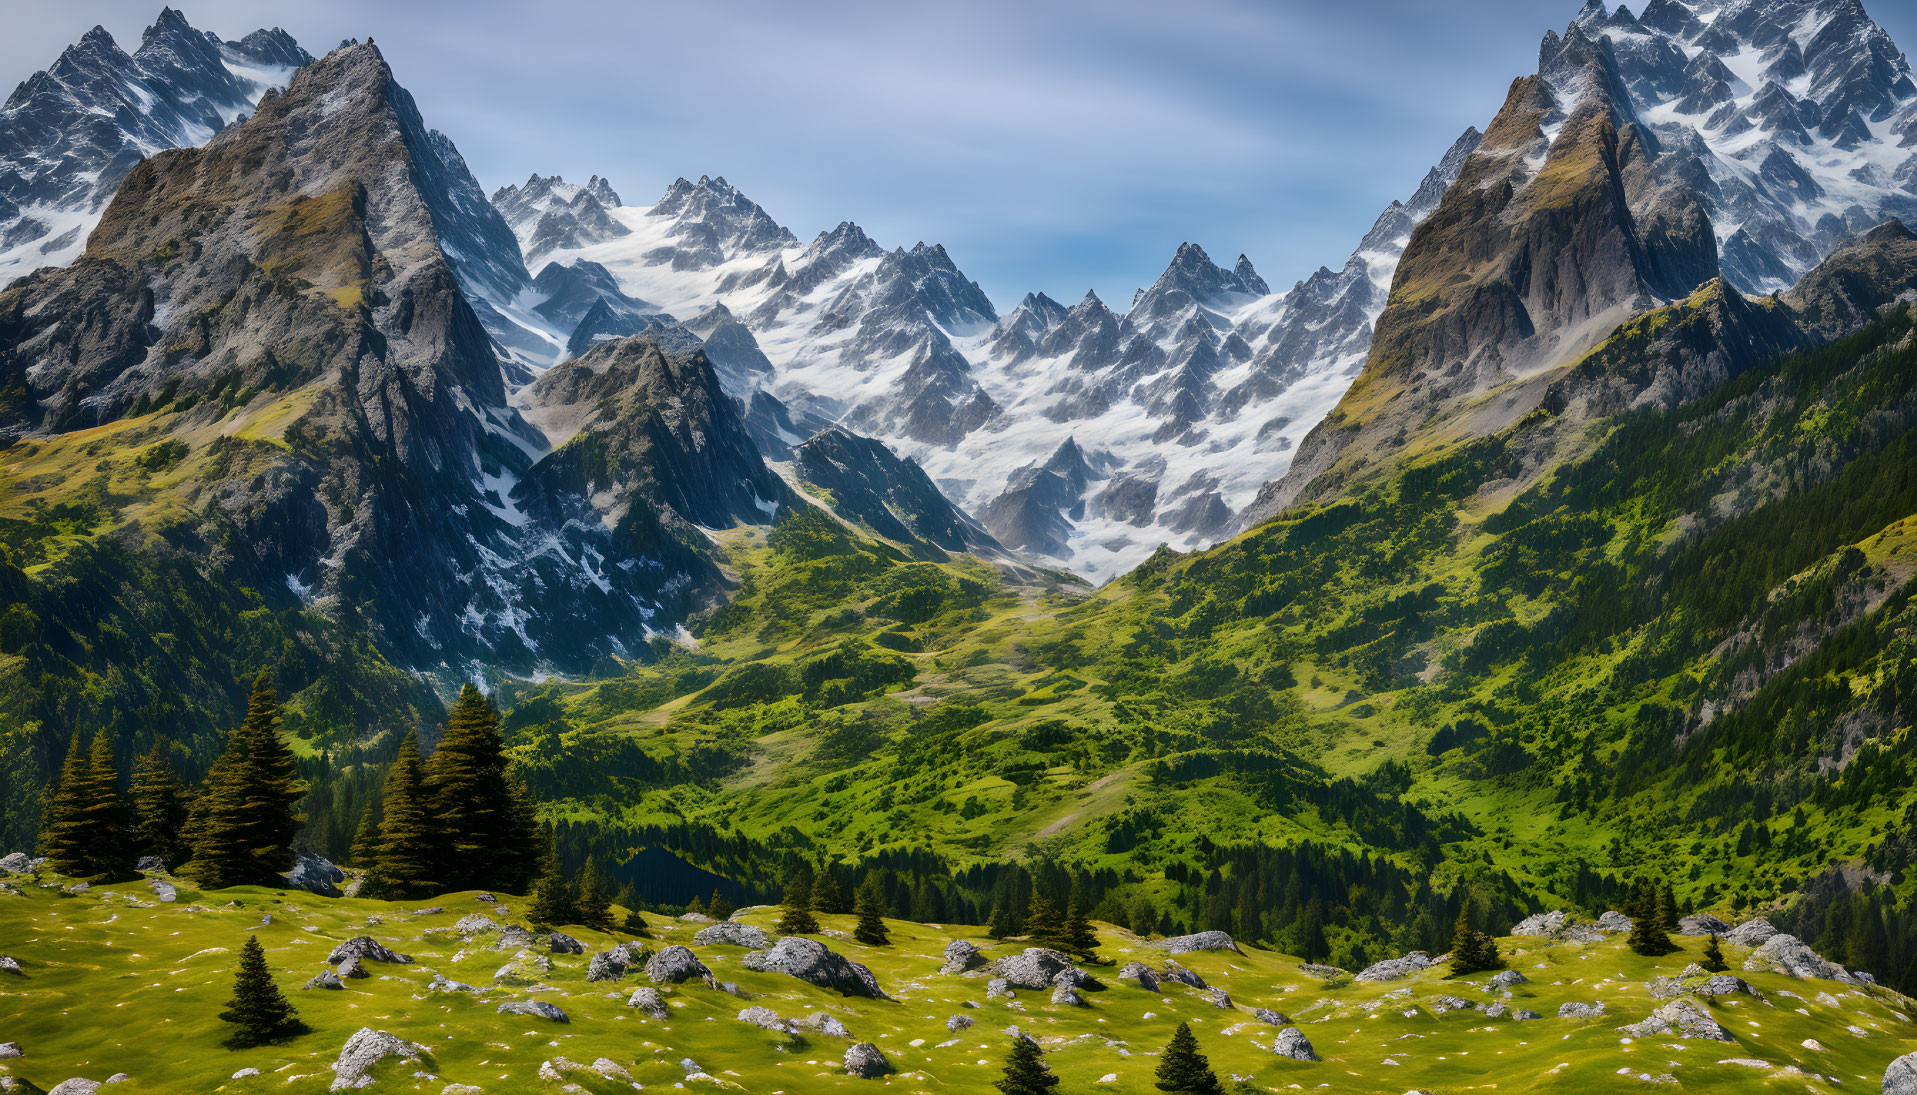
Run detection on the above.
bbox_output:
[1246,0,1917,522]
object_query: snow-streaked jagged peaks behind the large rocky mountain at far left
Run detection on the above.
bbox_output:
[0,8,312,284]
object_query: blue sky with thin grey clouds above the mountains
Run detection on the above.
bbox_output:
[0,0,1917,309]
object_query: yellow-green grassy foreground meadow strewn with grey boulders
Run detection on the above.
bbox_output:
[0,882,1917,1095]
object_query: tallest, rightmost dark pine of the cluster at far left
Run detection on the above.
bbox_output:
[194,673,303,890]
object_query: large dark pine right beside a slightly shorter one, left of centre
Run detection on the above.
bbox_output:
[426,683,539,892]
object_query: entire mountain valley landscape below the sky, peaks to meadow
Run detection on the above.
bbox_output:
[0,0,1917,1095]
